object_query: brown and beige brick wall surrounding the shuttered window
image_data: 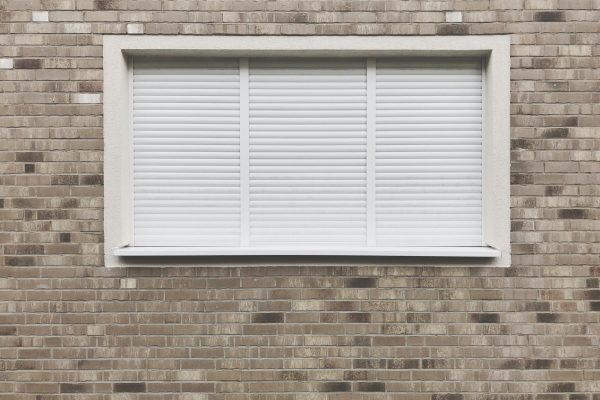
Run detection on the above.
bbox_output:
[0,0,600,400]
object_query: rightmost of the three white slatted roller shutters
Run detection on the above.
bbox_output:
[375,60,482,247]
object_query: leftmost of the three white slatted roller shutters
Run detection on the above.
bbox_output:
[133,59,240,246]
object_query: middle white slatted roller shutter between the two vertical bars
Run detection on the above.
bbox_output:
[250,59,366,246]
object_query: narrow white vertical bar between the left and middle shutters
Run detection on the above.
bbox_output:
[240,58,250,247]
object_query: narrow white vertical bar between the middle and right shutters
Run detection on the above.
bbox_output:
[367,58,377,247]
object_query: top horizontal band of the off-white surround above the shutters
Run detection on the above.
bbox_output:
[104,35,509,57]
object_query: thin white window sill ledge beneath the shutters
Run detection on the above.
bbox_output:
[113,246,502,258]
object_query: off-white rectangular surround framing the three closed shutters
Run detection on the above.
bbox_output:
[103,35,511,267]
